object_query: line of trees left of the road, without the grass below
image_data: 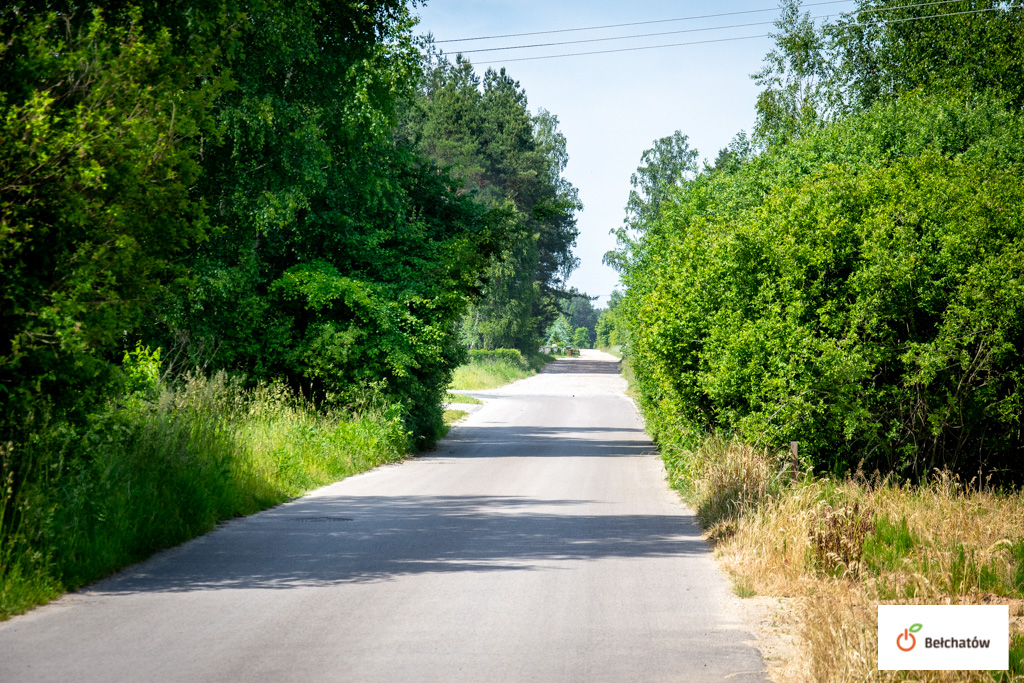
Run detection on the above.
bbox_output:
[0,0,580,442]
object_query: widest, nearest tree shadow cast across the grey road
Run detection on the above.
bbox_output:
[94,485,709,594]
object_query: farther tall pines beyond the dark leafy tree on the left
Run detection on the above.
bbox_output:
[402,50,583,354]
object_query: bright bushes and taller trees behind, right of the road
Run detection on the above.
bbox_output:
[598,0,1024,481]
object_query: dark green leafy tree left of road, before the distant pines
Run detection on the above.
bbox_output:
[166,0,500,445]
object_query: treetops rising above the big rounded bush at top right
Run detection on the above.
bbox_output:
[753,0,1024,146]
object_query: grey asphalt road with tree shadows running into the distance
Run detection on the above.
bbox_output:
[0,351,765,683]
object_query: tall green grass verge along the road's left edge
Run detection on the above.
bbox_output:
[0,376,408,620]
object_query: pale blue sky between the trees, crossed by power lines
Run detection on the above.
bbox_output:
[415,0,854,305]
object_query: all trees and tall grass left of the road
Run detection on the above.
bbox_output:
[0,0,577,617]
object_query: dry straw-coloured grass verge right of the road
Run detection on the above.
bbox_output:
[666,438,1024,681]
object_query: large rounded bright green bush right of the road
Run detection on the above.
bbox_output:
[622,96,1024,476]
